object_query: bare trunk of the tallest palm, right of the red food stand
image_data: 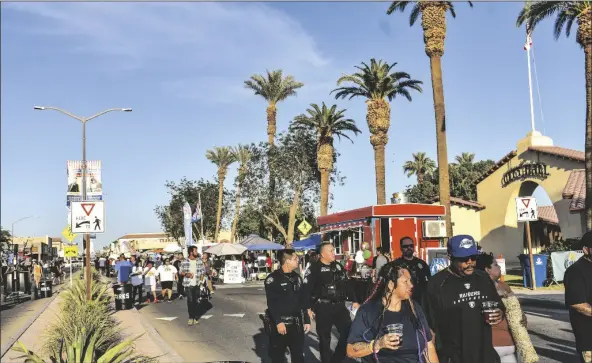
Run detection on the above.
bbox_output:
[430,55,453,237]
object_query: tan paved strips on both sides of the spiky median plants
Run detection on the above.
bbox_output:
[1,288,183,362]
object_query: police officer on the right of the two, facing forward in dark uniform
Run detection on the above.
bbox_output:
[304,242,360,363]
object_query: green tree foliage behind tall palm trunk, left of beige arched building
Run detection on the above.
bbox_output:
[405,153,495,203]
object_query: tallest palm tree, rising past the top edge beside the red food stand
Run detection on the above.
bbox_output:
[386,0,473,236]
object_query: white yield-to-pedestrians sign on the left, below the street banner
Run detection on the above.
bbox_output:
[70,201,105,235]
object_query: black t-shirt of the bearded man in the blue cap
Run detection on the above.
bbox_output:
[426,269,505,363]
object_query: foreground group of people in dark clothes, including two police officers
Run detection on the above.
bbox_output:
[263,232,592,363]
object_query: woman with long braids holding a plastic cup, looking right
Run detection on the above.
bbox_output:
[347,262,439,363]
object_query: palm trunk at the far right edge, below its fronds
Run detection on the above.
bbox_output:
[584,42,592,231]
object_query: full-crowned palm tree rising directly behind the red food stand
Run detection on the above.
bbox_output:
[331,58,423,204]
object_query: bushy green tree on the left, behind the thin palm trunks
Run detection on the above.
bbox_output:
[154,177,234,239]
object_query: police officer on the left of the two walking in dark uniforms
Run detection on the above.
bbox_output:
[265,249,310,363]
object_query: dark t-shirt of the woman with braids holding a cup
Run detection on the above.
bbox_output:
[347,301,432,363]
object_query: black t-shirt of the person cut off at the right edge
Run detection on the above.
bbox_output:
[563,257,592,351]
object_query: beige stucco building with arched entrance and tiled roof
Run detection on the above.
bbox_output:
[438,131,585,264]
